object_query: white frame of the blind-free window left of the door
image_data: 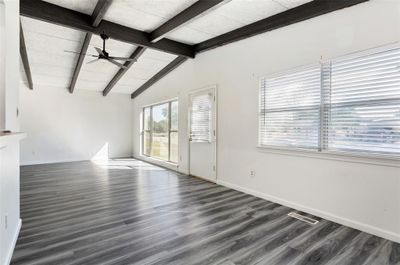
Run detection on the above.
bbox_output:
[140,98,179,164]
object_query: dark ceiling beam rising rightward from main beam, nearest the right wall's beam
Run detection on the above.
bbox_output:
[150,0,224,42]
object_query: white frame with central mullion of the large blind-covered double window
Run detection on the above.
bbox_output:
[257,43,400,161]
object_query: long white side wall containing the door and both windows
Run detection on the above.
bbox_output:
[133,0,400,242]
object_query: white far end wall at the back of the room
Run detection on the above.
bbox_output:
[20,85,133,165]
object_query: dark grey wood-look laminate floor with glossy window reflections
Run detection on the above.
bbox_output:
[12,159,400,265]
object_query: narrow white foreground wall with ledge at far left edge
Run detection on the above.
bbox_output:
[0,0,21,264]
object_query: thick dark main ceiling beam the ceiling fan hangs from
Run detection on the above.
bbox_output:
[20,0,194,58]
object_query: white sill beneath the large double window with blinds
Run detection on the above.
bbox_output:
[257,145,400,167]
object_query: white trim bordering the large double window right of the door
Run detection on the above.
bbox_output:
[257,42,400,164]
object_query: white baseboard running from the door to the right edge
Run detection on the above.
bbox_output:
[217,179,400,243]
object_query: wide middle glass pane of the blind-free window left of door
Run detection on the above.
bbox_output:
[151,103,169,160]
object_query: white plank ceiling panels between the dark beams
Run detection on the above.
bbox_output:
[21,0,311,94]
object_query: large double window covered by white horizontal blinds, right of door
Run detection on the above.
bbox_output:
[259,46,400,155]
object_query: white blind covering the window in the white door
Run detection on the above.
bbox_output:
[190,94,213,142]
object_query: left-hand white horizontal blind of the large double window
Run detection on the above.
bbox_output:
[259,65,321,149]
